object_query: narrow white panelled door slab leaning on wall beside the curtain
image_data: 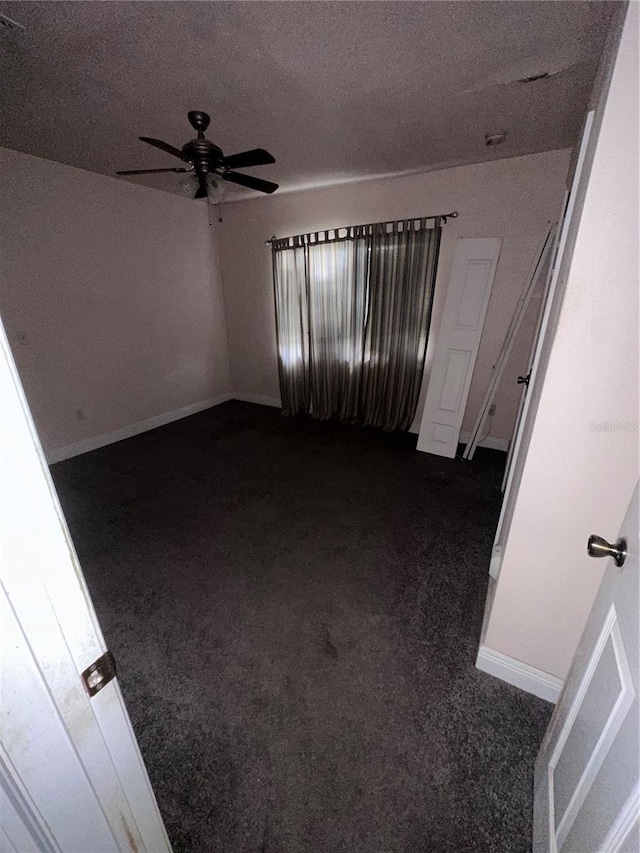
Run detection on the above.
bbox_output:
[417,237,502,459]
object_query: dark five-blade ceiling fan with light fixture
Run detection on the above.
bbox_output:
[116,110,278,198]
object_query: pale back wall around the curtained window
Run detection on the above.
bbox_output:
[219,150,570,438]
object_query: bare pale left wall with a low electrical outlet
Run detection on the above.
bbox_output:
[0,149,231,451]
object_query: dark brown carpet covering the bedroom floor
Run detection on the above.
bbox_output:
[52,402,551,853]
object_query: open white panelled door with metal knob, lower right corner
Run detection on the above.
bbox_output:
[534,487,640,853]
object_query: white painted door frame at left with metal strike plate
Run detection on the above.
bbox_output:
[0,325,171,853]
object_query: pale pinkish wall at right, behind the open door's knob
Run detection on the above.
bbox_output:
[485,3,640,678]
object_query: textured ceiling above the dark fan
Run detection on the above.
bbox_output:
[0,0,615,198]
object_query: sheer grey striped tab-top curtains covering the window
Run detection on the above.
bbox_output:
[272,219,442,430]
